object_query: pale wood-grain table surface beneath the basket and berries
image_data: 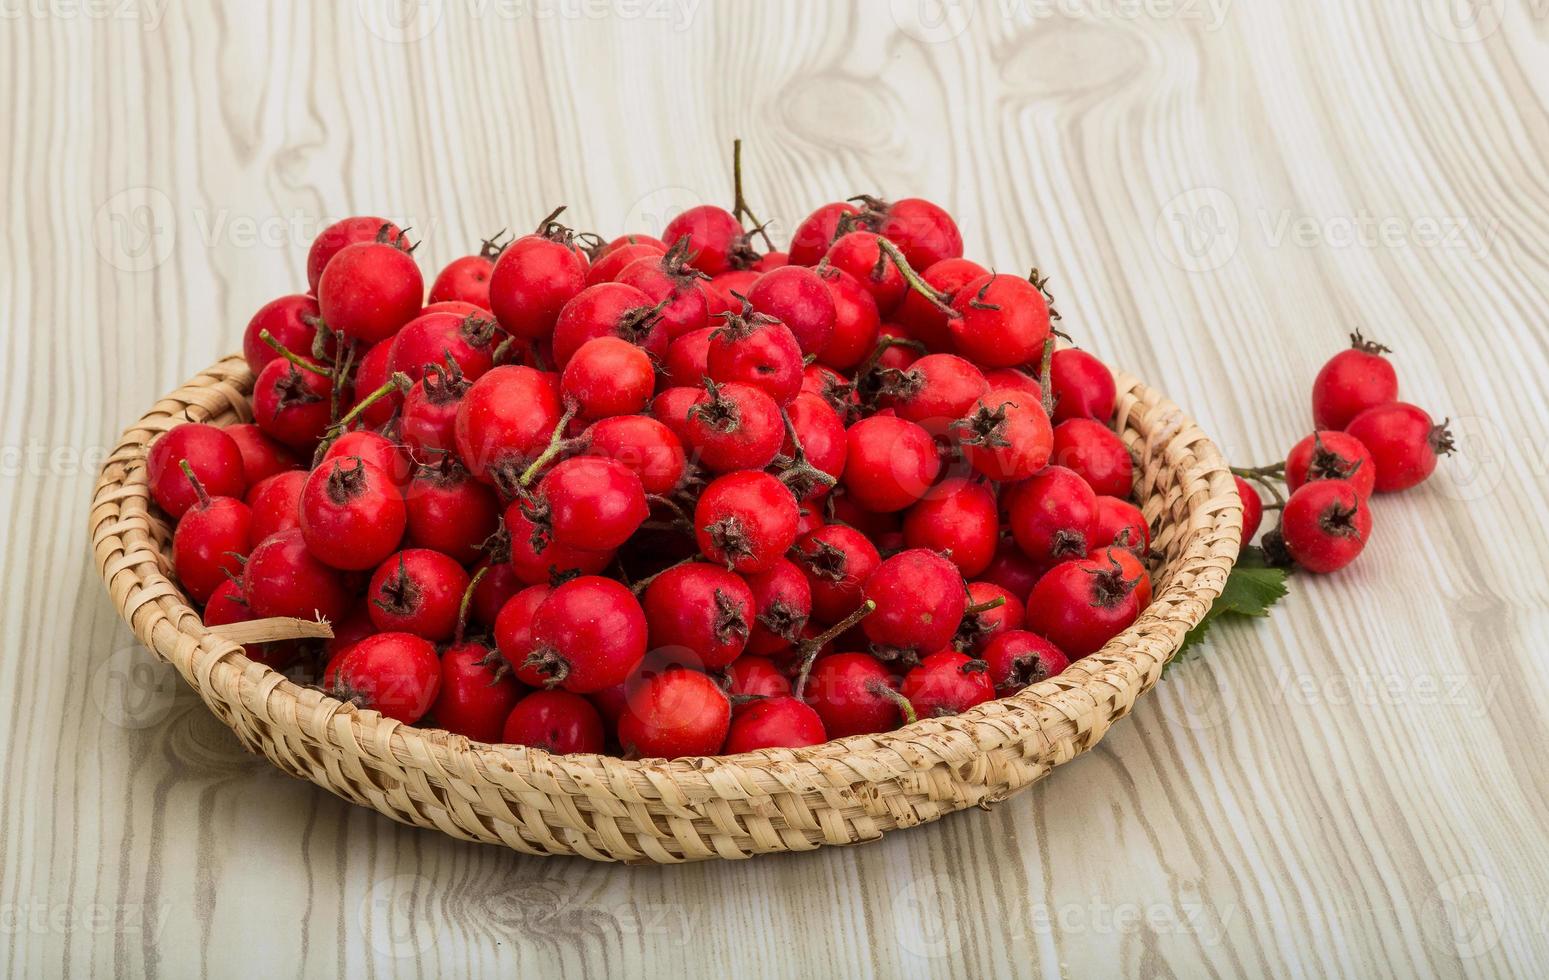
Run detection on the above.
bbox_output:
[0,0,1549,977]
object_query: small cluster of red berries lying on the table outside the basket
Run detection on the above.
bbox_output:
[1231,333,1453,573]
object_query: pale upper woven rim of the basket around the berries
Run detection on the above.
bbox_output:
[90,355,1241,856]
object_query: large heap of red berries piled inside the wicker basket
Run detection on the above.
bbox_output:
[149,158,1151,757]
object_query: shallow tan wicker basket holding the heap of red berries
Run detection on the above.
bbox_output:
[91,356,1242,864]
